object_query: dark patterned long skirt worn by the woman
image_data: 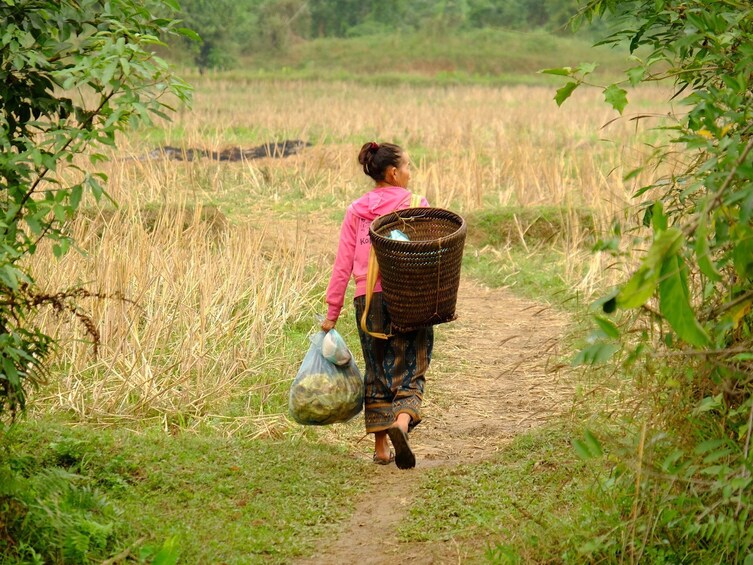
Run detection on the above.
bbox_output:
[354,292,434,433]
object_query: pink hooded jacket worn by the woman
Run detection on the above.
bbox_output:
[327,186,429,322]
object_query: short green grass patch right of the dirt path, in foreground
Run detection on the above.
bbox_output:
[401,423,604,563]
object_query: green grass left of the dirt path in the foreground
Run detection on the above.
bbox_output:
[0,416,372,565]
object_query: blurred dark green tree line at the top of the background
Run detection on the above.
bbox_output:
[180,0,578,68]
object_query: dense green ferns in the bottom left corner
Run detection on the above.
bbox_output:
[0,427,178,565]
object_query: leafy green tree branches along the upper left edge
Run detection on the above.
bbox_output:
[0,0,188,415]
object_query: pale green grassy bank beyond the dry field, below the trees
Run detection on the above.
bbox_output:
[185,29,628,86]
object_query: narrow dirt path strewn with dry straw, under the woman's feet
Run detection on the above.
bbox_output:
[294,281,571,565]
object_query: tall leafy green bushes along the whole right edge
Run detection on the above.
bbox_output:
[545,0,753,563]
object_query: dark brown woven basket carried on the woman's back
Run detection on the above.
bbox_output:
[369,208,467,332]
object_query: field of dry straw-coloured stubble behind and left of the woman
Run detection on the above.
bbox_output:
[26,80,666,434]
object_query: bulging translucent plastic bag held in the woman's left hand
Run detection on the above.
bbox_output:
[288,331,364,426]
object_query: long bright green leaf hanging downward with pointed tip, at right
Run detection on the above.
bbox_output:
[659,254,711,347]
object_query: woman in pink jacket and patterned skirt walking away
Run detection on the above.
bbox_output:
[322,142,434,469]
